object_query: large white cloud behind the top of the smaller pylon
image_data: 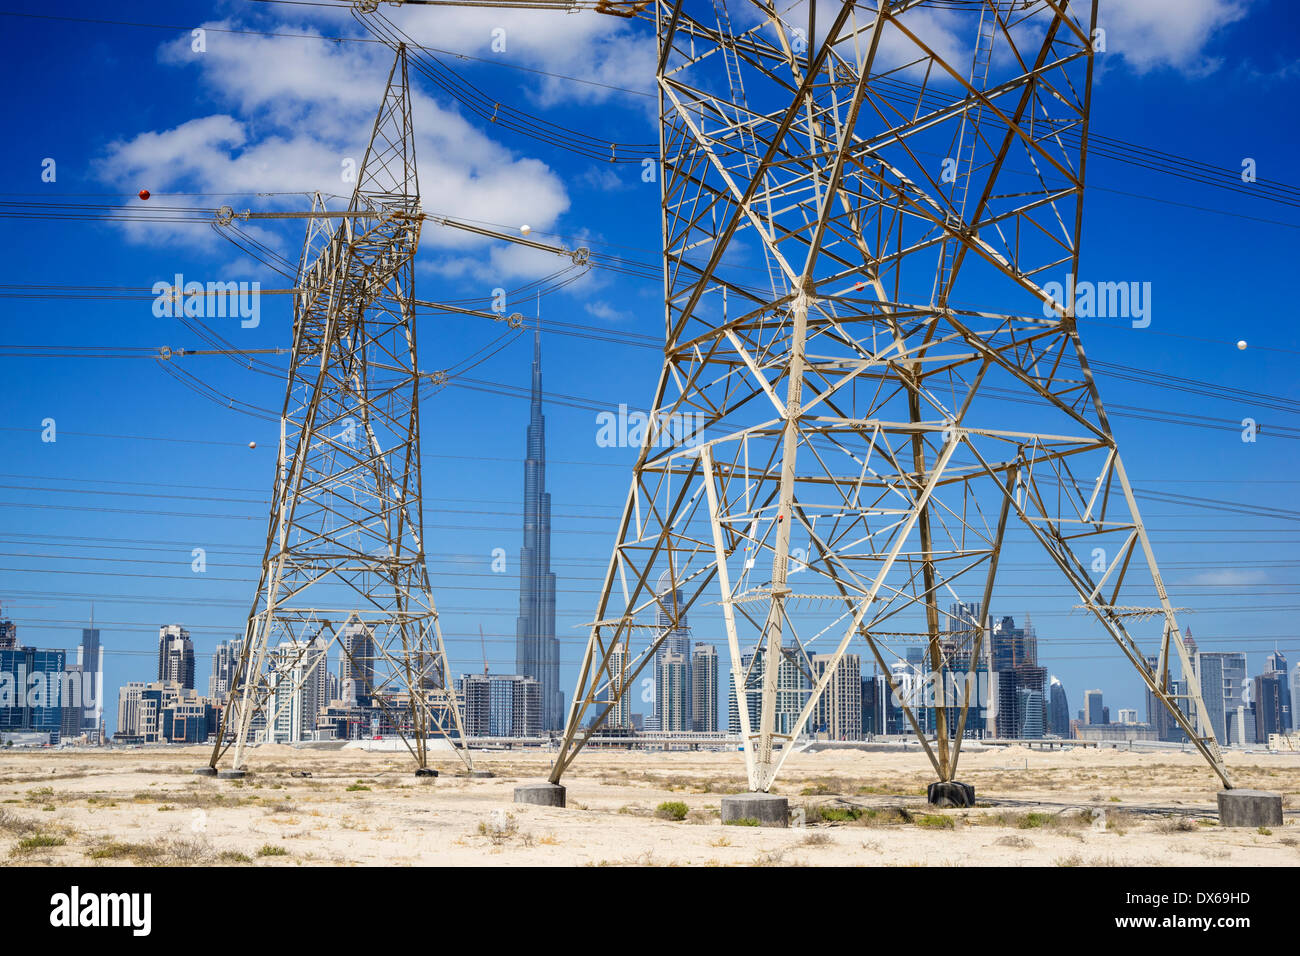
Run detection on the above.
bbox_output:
[99,23,569,271]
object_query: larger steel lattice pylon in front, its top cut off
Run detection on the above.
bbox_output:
[550,0,1231,791]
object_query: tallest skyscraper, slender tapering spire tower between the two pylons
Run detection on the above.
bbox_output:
[515,332,564,730]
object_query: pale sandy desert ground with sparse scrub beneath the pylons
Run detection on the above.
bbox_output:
[0,747,1300,866]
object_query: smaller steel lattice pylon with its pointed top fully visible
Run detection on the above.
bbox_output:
[211,48,471,773]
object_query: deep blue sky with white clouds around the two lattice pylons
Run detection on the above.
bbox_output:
[0,0,1300,726]
